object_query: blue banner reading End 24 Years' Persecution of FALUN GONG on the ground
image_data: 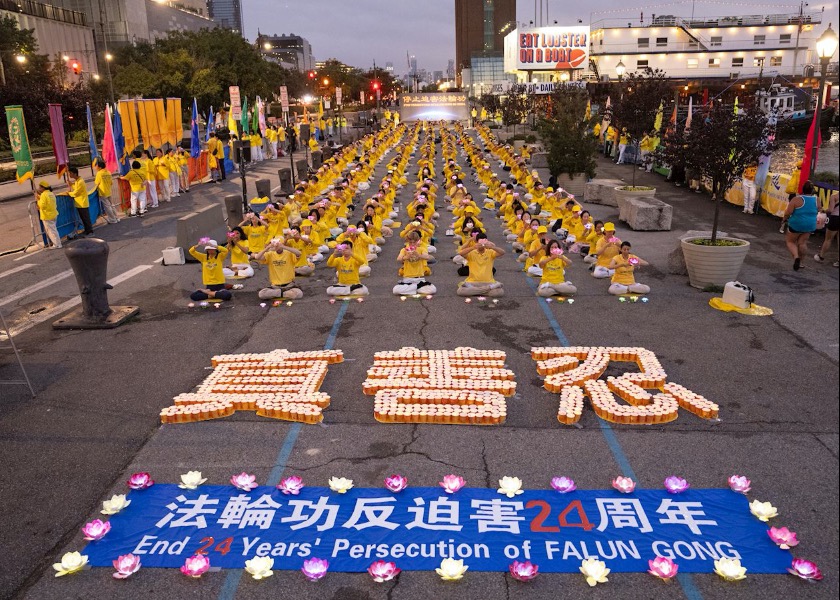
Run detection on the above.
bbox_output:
[84,484,791,573]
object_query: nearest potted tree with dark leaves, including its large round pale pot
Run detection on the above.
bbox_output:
[657,103,773,289]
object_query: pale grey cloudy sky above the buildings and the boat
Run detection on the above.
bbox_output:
[242,0,838,74]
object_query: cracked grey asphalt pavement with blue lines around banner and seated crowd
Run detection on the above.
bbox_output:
[0,131,840,600]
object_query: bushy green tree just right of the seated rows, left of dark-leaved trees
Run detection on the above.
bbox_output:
[537,87,598,195]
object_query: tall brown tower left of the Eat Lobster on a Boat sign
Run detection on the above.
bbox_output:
[455,0,516,83]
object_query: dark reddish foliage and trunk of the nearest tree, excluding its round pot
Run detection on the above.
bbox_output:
[656,103,774,246]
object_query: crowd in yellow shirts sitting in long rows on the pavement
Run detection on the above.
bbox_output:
[190,121,650,301]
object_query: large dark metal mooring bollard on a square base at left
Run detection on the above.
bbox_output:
[53,238,140,329]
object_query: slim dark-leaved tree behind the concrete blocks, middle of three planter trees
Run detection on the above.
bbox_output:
[612,68,673,187]
